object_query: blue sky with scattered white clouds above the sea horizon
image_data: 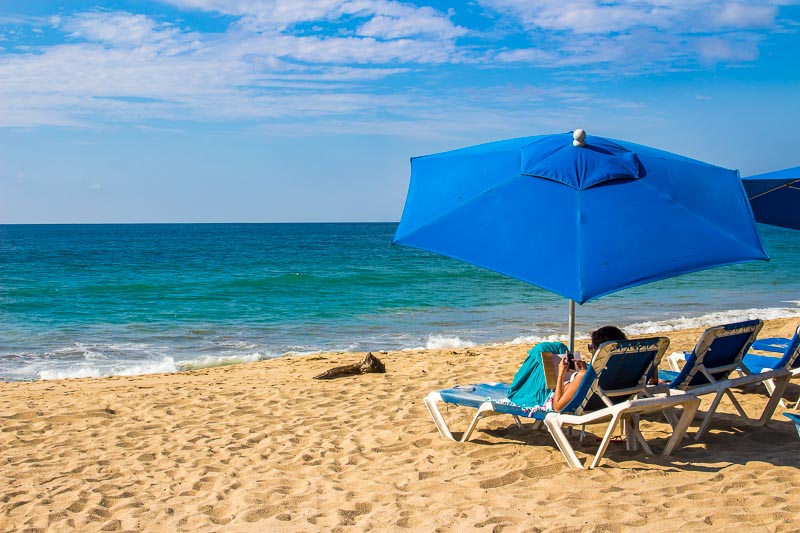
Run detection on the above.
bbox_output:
[0,0,800,223]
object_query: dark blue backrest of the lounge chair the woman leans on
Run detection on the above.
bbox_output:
[561,337,669,414]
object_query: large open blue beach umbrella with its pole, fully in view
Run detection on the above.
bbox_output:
[392,130,768,348]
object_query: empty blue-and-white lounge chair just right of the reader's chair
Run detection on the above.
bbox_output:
[652,320,789,440]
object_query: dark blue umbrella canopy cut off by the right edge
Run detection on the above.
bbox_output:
[742,167,800,229]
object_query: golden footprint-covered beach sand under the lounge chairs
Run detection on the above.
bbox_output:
[0,319,800,532]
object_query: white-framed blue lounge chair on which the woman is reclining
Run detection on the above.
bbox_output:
[425,337,700,468]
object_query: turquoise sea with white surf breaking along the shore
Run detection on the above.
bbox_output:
[0,223,800,381]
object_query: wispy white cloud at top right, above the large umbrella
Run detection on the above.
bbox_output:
[479,0,797,67]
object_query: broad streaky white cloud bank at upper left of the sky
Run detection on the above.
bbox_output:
[0,2,468,126]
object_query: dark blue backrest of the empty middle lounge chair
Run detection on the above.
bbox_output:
[669,320,764,390]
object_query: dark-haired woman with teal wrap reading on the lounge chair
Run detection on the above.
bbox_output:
[507,326,627,412]
